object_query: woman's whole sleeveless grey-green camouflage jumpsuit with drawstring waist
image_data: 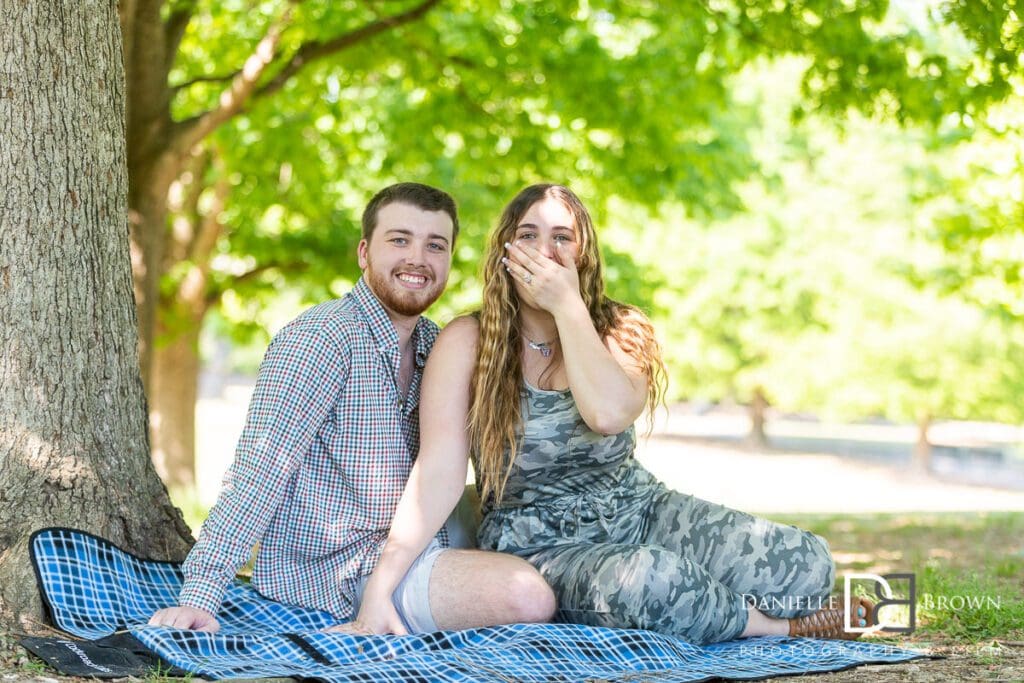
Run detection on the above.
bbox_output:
[477,386,835,645]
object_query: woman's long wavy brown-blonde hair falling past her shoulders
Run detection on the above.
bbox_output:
[468,184,666,503]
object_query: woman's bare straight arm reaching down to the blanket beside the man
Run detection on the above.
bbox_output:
[335,316,478,635]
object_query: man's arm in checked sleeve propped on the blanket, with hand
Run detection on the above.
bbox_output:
[150,327,349,631]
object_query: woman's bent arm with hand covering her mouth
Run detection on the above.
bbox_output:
[508,242,647,434]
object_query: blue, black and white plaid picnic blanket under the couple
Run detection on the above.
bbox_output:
[30,528,928,683]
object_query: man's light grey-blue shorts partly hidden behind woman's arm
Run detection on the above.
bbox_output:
[354,497,476,633]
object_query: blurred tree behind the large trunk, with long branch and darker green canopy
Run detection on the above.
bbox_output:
[136,0,1015,483]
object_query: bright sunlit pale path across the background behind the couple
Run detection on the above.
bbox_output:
[196,380,1024,513]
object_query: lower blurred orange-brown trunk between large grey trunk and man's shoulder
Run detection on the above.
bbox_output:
[150,315,203,488]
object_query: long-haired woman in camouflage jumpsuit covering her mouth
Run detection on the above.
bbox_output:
[356,184,871,644]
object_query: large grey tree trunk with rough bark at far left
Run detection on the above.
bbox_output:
[0,0,191,631]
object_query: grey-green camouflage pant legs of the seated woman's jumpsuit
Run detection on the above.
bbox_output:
[481,481,835,645]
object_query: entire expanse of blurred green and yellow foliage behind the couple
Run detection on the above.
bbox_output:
[167,0,1024,428]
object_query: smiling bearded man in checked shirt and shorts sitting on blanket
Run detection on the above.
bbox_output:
[150,182,554,632]
